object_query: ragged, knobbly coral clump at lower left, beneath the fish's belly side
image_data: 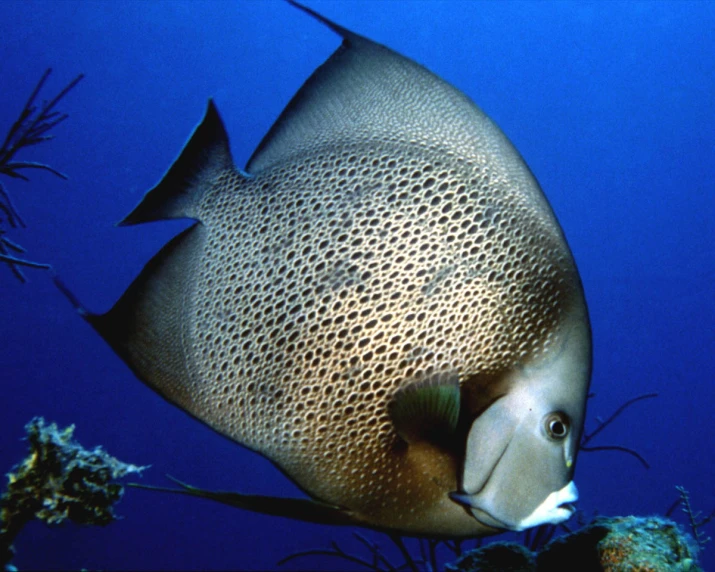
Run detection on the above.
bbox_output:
[0,417,146,565]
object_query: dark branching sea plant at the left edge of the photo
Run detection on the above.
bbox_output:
[0,68,84,282]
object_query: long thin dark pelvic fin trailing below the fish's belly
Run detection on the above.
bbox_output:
[130,477,364,526]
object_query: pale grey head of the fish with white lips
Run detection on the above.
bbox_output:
[450,308,591,531]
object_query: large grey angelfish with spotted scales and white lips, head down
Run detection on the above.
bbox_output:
[58,1,591,538]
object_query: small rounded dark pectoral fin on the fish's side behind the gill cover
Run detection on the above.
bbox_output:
[390,372,460,443]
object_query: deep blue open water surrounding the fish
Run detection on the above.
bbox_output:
[0,0,715,570]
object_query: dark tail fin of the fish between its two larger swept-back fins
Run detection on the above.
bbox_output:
[119,99,233,226]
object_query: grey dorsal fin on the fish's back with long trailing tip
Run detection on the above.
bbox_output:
[246,0,520,174]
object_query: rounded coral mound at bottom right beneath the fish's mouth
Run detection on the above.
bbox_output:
[446,516,702,572]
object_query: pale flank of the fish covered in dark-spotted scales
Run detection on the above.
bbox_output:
[179,135,577,524]
